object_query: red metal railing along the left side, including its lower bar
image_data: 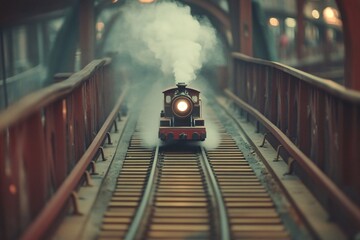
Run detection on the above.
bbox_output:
[0,59,124,239]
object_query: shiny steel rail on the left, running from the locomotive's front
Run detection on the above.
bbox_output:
[125,145,159,240]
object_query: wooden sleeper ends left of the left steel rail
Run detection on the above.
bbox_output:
[99,133,155,239]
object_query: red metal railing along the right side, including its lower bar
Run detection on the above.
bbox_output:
[225,53,360,234]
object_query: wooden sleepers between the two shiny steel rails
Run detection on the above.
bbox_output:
[144,150,216,239]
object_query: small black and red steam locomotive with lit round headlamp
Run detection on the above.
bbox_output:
[159,83,206,142]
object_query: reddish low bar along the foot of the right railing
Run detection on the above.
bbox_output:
[225,89,360,229]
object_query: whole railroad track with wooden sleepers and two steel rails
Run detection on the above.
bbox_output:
[99,125,290,239]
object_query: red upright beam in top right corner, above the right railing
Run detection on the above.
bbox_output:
[336,0,360,91]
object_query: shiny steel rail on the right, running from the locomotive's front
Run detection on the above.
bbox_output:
[201,147,231,240]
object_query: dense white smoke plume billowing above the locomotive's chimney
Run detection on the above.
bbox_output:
[107,1,217,83]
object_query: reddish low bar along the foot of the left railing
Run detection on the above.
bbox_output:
[21,84,127,240]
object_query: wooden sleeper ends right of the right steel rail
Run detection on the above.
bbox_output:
[206,132,290,239]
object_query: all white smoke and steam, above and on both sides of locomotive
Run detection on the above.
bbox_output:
[99,0,225,148]
